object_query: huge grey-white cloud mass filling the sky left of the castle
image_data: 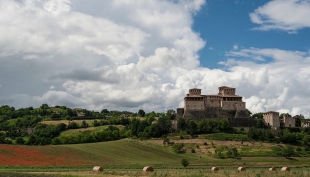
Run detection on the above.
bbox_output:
[0,0,205,110]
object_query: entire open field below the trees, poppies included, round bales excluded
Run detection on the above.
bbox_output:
[0,139,310,177]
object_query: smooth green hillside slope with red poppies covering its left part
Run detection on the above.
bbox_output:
[0,139,189,168]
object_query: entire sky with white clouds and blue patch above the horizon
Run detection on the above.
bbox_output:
[0,0,310,117]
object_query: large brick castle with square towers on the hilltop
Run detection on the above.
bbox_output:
[177,86,249,120]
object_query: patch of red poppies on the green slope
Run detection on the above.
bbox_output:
[0,144,110,166]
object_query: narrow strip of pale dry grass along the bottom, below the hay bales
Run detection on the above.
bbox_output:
[0,168,310,177]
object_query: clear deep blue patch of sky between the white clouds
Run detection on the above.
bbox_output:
[193,0,310,68]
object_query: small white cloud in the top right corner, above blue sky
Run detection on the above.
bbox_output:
[250,0,310,33]
